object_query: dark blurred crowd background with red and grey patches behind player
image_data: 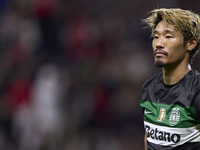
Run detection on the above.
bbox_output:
[0,0,200,150]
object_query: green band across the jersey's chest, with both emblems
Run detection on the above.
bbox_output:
[140,100,200,128]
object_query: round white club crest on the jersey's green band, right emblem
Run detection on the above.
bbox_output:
[169,107,180,126]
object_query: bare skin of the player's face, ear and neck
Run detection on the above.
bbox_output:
[152,21,197,85]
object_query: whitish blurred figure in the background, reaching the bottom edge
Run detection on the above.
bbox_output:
[15,64,68,150]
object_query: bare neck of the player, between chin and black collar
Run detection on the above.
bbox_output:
[163,64,191,85]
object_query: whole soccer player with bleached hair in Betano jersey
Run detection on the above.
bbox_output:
[140,8,200,150]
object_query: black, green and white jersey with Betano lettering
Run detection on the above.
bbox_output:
[140,70,200,150]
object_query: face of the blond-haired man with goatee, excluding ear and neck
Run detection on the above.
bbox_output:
[152,21,188,67]
